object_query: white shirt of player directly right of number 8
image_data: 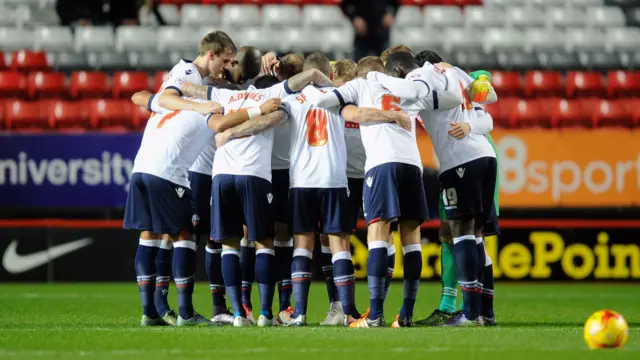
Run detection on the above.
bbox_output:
[336,78,422,172]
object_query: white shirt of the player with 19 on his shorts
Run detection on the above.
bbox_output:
[406,64,495,172]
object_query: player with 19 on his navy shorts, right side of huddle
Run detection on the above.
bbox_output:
[381,53,497,326]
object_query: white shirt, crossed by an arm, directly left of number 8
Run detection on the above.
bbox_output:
[209,81,291,181]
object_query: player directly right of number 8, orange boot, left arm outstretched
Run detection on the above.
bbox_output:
[308,54,461,328]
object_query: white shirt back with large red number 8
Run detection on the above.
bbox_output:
[283,85,347,188]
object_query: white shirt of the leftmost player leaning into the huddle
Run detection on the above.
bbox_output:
[132,111,213,188]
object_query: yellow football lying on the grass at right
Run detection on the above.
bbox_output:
[584,310,629,349]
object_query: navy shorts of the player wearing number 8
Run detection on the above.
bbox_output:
[289,188,351,234]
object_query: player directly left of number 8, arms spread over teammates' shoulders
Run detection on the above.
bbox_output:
[185,70,330,327]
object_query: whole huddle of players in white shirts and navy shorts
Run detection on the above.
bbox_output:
[124,31,498,328]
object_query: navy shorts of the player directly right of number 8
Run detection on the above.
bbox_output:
[363,163,429,225]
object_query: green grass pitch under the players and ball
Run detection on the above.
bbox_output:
[0,283,640,360]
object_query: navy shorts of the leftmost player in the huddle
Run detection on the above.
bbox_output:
[123,173,197,234]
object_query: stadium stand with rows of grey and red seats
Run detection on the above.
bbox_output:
[0,0,640,131]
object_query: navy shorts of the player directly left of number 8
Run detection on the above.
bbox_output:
[211,174,274,241]
